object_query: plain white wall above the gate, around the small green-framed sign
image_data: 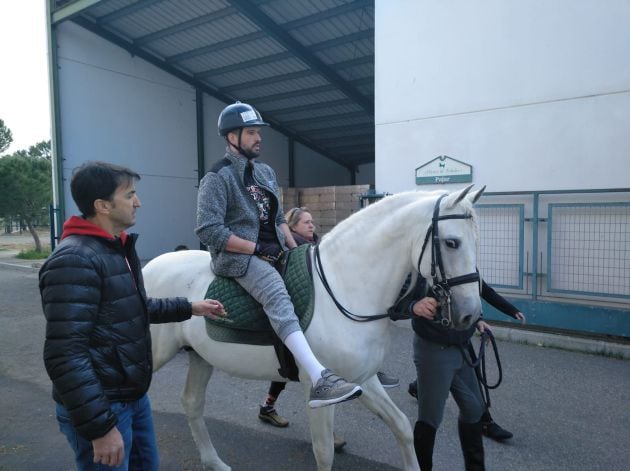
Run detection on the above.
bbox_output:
[375,0,630,192]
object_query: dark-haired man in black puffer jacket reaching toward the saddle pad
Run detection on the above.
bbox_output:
[39,162,225,470]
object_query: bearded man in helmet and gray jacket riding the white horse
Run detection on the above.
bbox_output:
[196,102,362,407]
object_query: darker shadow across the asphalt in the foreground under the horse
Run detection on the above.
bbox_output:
[0,376,396,471]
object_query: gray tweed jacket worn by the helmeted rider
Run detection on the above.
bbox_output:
[195,151,286,277]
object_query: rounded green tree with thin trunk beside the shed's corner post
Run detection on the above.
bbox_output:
[0,142,52,252]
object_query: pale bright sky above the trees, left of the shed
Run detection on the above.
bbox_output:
[0,0,51,154]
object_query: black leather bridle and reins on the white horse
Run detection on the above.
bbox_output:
[313,194,480,327]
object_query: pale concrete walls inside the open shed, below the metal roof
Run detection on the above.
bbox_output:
[57,22,366,259]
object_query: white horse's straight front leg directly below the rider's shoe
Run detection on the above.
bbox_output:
[300,378,335,471]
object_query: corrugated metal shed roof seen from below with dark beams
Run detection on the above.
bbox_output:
[53,0,374,168]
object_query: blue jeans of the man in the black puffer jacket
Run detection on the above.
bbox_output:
[57,394,160,471]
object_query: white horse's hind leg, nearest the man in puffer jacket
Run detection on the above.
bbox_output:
[182,350,232,471]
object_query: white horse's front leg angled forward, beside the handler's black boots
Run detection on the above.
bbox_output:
[359,375,420,471]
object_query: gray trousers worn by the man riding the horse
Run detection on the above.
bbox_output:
[234,256,301,342]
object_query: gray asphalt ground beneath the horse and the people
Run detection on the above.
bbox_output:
[0,264,630,471]
